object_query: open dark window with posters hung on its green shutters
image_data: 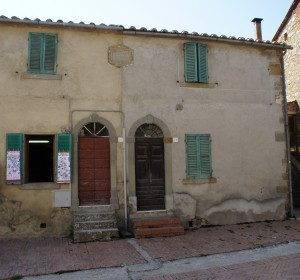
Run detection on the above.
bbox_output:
[6,133,72,184]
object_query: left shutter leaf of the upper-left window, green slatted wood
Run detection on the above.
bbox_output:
[28,33,43,73]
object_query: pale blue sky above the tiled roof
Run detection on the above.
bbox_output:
[0,0,293,40]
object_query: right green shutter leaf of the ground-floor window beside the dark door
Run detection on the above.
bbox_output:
[198,134,212,178]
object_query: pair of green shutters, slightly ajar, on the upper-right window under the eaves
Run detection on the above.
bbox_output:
[184,42,208,83]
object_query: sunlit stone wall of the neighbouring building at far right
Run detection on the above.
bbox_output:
[278,4,300,102]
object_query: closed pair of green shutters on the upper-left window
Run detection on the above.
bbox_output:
[28,33,57,74]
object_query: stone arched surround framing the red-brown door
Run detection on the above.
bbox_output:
[71,113,119,210]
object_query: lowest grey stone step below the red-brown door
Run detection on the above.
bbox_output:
[73,228,119,242]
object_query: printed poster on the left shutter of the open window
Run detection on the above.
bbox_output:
[6,151,21,183]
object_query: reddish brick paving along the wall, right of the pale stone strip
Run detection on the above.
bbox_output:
[137,220,300,261]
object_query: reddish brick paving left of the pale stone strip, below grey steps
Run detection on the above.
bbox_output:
[0,238,146,279]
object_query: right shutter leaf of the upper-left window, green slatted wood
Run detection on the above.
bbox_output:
[44,34,57,73]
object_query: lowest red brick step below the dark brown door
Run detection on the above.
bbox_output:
[134,226,184,238]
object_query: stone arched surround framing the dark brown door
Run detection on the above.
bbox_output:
[127,115,173,214]
